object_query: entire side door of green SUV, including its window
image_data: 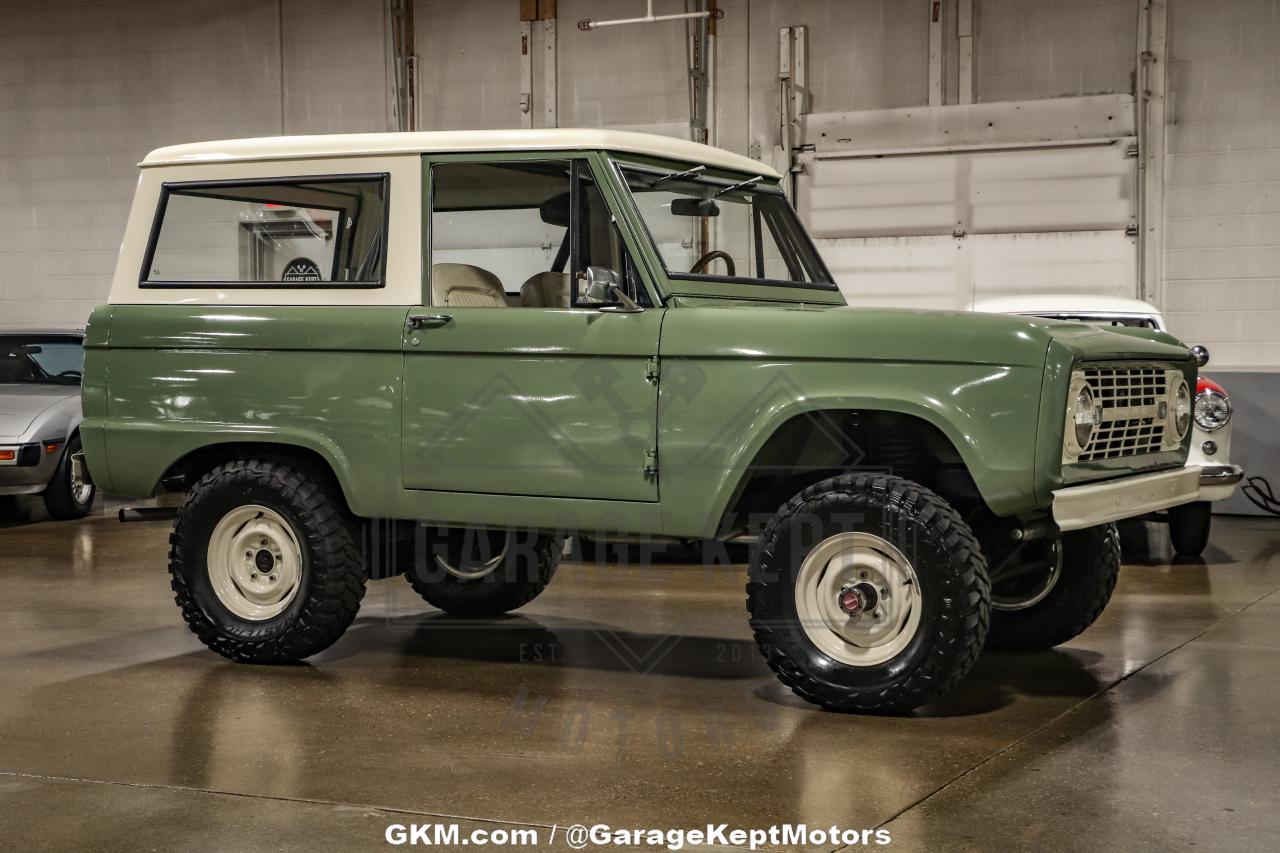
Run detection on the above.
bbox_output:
[402,155,663,501]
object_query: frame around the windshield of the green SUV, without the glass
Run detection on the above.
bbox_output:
[609,155,846,305]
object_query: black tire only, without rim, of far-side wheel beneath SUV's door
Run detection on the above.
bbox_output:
[404,530,563,619]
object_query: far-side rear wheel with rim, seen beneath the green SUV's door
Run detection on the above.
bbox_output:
[404,528,563,619]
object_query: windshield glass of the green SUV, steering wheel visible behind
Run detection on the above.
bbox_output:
[622,167,835,289]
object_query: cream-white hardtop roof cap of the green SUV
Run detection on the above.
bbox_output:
[138,128,780,178]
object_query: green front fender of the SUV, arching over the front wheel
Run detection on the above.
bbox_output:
[659,300,1051,535]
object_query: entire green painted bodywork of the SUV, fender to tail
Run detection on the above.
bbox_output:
[82,143,1194,537]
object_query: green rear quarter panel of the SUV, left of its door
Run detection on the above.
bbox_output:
[84,305,408,515]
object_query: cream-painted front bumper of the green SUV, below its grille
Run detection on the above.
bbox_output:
[1053,465,1201,532]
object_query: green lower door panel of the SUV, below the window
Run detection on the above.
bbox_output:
[403,307,666,501]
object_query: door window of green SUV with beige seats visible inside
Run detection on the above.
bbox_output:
[430,160,648,307]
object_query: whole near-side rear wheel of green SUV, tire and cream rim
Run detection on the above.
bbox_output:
[169,460,365,663]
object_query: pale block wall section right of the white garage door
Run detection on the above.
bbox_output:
[1162,0,1280,370]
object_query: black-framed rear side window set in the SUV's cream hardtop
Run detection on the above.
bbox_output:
[141,174,387,287]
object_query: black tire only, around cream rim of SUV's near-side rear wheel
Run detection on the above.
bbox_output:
[169,459,366,663]
